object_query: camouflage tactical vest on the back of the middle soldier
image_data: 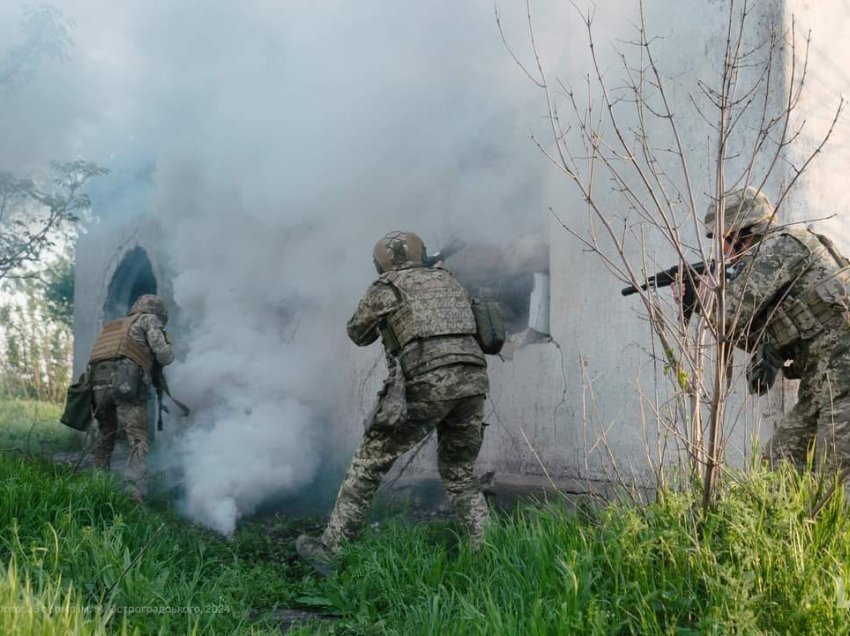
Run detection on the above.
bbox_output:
[381,267,475,349]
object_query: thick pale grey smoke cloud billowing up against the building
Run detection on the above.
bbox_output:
[0,0,576,534]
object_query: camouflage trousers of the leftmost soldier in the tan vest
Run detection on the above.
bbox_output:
[94,386,150,498]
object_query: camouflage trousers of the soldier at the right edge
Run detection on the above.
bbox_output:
[764,332,850,468]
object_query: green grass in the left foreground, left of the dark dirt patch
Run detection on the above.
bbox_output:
[0,454,296,634]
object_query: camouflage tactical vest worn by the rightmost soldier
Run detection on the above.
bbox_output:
[765,229,850,357]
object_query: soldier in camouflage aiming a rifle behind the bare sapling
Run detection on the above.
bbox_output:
[705,188,850,467]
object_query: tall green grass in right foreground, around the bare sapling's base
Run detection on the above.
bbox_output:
[290,469,850,635]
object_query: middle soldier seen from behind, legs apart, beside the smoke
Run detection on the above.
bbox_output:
[296,232,489,570]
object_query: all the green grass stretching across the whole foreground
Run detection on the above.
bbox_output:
[0,402,850,636]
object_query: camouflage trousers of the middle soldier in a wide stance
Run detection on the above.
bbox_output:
[322,395,487,552]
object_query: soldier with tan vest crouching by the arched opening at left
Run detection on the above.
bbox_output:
[89,294,174,501]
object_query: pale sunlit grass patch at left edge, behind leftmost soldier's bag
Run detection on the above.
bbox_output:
[0,398,83,455]
